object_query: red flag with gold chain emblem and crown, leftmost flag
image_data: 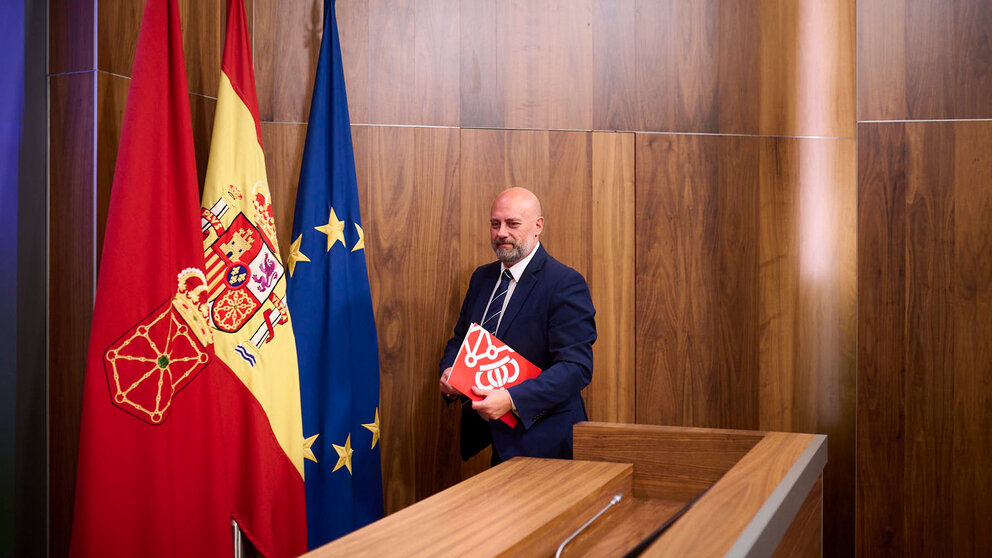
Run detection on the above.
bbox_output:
[70,0,306,557]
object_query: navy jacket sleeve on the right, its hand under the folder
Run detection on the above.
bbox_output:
[509,271,596,428]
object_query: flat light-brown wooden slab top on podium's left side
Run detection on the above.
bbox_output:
[307,457,632,558]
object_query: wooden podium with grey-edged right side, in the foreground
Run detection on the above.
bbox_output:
[306,422,827,558]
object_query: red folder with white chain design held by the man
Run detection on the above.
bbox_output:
[448,323,541,428]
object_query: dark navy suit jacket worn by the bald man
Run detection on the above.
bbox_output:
[440,245,596,464]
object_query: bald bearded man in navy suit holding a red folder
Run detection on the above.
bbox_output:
[440,188,596,465]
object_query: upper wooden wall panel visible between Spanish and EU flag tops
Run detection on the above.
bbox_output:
[256,0,322,122]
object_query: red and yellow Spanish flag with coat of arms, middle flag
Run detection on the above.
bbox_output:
[200,0,306,551]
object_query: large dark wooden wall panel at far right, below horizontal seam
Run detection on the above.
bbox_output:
[857,122,992,556]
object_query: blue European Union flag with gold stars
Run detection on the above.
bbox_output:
[287,1,383,548]
